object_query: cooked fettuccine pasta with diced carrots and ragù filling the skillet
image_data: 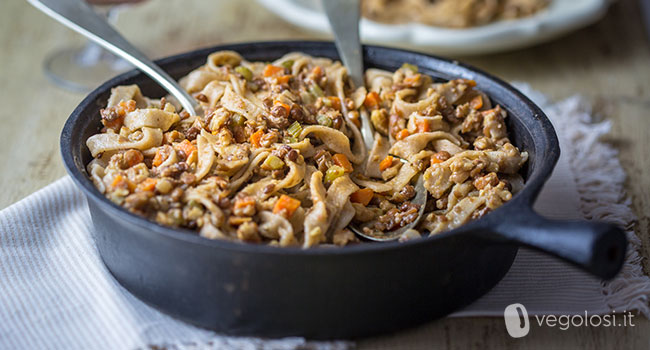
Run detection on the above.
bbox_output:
[86,51,527,248]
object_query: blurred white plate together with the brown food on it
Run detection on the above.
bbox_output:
[258,0,611,55]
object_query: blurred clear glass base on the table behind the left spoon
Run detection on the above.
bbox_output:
[43,43,132,92]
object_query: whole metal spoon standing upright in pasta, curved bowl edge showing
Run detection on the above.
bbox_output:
[321,0,427,241]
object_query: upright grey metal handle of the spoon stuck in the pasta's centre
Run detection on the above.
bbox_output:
[321,0,375,150]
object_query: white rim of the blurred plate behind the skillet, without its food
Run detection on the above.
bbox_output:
[258,0,610,55]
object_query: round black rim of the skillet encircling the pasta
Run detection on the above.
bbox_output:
[60,40,560,257]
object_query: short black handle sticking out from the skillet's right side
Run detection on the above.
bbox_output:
[496,208,627,280]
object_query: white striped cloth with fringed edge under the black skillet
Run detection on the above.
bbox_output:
[0,87,650,349]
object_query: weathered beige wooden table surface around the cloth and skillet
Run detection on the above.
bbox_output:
[0,0,650,349]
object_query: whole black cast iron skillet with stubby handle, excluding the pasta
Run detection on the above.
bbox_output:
[61,42,627,339]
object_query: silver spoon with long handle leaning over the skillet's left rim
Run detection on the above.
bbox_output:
[27,0,202,115]
